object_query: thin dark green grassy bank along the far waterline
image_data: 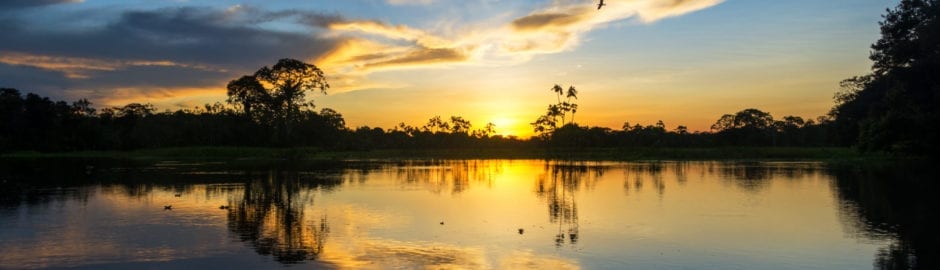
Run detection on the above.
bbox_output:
[0,147,888,162]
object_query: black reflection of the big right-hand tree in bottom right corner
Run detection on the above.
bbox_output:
[830,164,940,269]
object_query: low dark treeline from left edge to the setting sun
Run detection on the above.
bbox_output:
[0,88,525,152]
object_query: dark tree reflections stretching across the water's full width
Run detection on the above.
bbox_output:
[0,161,940,269]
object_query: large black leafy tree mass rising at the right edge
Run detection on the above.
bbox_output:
[830,0,940,155]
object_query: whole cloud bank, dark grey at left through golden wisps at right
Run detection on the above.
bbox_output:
[0,0,722,108]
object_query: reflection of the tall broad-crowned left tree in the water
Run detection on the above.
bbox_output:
[228,171,342,263]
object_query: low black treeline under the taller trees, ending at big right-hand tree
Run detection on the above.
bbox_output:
[0,88,835,152]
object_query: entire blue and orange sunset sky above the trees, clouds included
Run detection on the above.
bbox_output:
[0,0,898,137]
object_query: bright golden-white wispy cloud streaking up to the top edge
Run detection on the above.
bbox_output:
[321,0,723,74]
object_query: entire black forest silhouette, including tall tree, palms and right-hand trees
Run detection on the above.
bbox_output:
[0,0,940,158]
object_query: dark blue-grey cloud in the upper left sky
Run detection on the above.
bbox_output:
[0,6,342,103]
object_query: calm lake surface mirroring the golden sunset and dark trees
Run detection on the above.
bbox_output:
[0,160,937,269]
